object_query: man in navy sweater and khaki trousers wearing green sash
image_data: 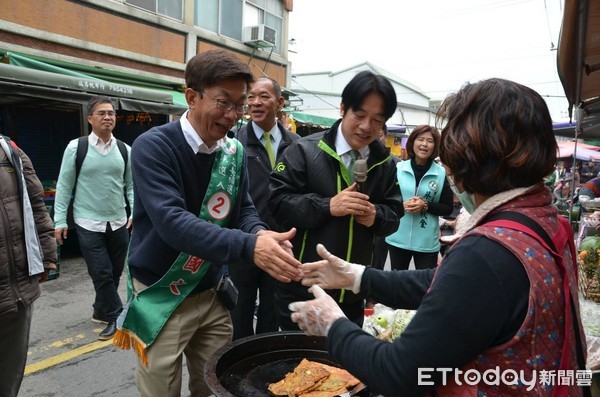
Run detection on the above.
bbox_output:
[114,51,301,397]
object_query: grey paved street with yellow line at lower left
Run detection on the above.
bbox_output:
[19,241,187,397]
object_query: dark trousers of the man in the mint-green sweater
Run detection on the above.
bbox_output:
[77,225,129,322]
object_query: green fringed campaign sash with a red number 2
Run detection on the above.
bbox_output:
[113,138,244,365]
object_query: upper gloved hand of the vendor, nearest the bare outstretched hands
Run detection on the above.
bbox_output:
[301,244,365,294]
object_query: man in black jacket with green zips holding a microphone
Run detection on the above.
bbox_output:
[269,71,403,330]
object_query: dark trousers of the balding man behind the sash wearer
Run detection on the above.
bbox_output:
[229,264,279,340]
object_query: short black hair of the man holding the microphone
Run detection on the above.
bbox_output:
[342,70,398,120]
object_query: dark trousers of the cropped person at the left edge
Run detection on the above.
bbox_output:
[0,303,33,397]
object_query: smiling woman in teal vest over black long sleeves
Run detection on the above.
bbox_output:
[385,125,453,270]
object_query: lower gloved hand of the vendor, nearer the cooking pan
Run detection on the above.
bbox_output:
[288,285,346,336]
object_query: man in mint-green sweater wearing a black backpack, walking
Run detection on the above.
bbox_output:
[54,96,133,340]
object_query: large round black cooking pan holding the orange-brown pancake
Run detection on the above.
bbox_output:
[204,331,368,397]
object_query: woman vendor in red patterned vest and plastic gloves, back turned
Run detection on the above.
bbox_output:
[290,79,591,397]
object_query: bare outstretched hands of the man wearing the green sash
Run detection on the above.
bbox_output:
[253,228,302,283]
